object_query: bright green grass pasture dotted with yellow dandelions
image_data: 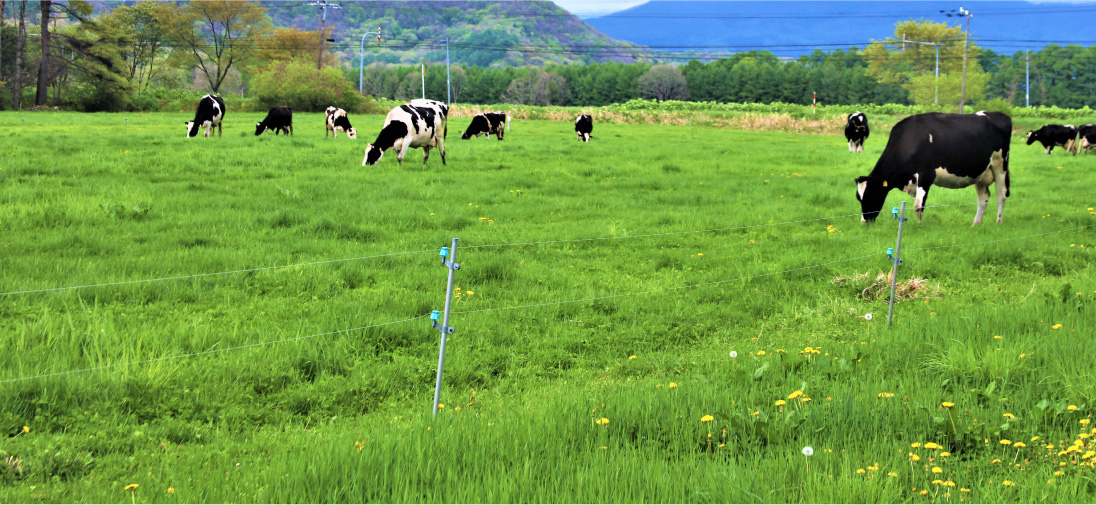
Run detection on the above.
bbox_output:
[0,112,1096,503]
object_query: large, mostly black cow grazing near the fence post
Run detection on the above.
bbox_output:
[856,111,1013,225]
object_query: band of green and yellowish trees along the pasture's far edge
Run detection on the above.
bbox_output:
[0,0,1096,111]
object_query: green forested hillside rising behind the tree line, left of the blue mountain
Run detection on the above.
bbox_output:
[261,0,642,67]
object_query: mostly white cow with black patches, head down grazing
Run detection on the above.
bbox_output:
[362,99,449,167]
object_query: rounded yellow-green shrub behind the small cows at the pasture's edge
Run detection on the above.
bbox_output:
[252,59,368,112]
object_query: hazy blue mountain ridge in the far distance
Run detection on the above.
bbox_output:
[586,0,1096,58]
